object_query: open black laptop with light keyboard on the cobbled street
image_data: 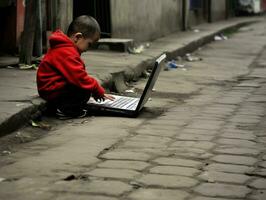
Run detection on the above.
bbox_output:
[88,54,166,117]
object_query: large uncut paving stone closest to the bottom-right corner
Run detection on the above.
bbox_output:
[194,183,251,198]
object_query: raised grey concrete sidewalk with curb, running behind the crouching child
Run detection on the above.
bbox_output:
[0,17,264,136]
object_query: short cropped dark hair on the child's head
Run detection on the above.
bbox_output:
[67,15,101,38]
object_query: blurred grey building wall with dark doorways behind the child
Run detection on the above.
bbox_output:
[0,0,266,53]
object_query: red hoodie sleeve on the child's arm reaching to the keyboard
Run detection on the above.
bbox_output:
[55,55,105,97]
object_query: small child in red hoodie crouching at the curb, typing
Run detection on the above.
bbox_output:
[37,15,114,117]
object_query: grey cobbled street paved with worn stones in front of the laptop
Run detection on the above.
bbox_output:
[0,16,266,200]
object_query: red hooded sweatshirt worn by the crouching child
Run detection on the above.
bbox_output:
[37,30,105,101]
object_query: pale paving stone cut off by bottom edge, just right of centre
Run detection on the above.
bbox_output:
[128,189,189,200]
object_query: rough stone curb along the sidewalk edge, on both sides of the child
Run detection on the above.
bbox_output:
[0,19,258,137]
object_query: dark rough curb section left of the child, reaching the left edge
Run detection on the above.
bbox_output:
[0,98,46,137]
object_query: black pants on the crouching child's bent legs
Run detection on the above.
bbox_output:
[48,86,91,116]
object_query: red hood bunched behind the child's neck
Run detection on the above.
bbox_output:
[49,30,74,49]
